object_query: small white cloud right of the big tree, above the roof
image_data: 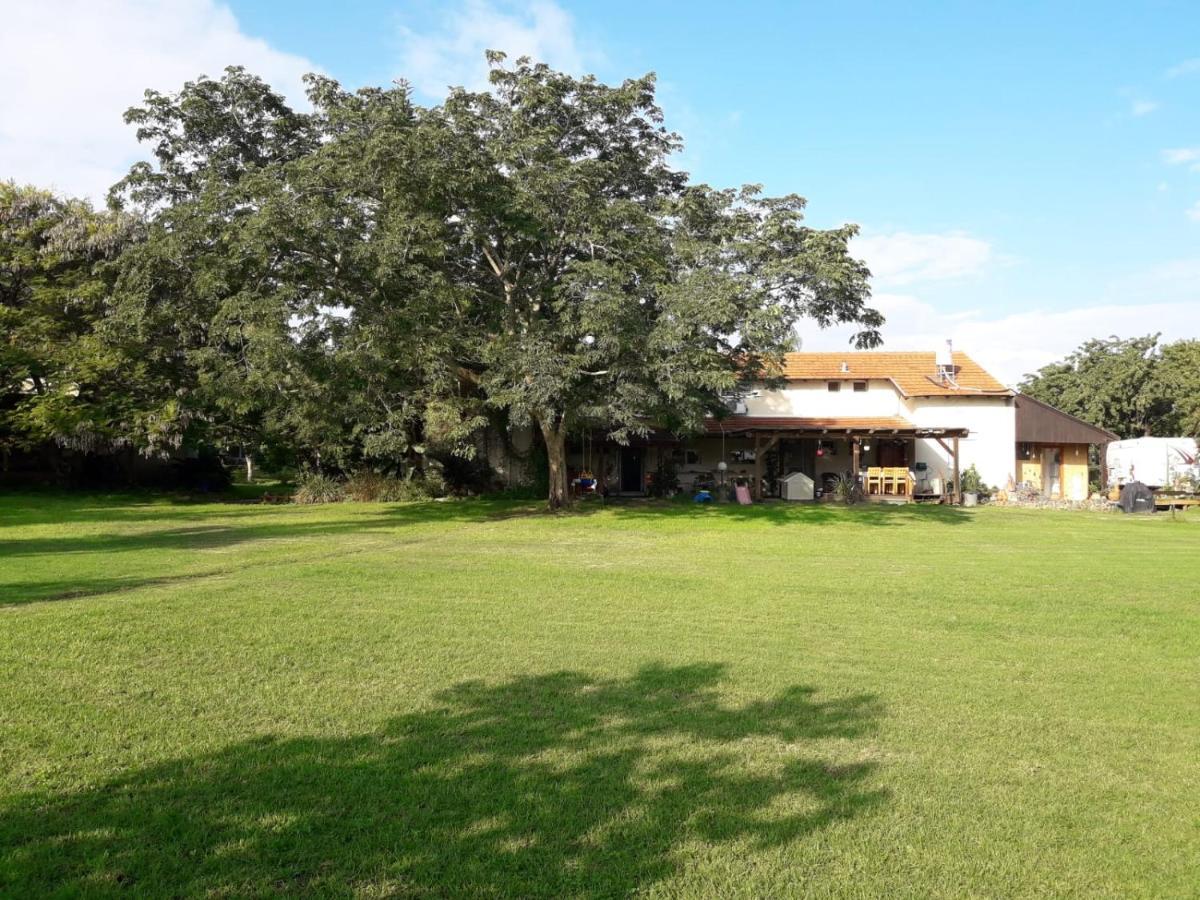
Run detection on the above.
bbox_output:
[851,232,992,287]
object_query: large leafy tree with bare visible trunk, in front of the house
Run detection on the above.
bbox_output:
[424,52,882,508]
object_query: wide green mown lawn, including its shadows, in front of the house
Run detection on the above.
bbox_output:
[0,494,1200,898]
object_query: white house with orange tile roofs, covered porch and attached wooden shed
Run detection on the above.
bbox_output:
[561,347,1114,499]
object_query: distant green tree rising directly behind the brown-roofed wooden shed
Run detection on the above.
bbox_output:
[1020,335,1170,438]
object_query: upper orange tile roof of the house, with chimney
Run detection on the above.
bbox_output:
[782,350,1012,397]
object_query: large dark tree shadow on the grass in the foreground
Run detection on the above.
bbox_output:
[0,665,886,898]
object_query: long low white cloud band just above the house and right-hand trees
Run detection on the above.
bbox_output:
[802,259,1200,385]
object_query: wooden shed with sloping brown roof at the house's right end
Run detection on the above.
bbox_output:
[1015,394,1117,500]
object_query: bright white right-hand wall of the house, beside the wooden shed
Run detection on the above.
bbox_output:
[904,396,1016,487]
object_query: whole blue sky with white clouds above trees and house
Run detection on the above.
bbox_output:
[0,0,1200,380]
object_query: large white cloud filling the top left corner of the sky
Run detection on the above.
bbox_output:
[0,0,316,199]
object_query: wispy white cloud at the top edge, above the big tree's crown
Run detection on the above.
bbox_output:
[398,0,595,98]
